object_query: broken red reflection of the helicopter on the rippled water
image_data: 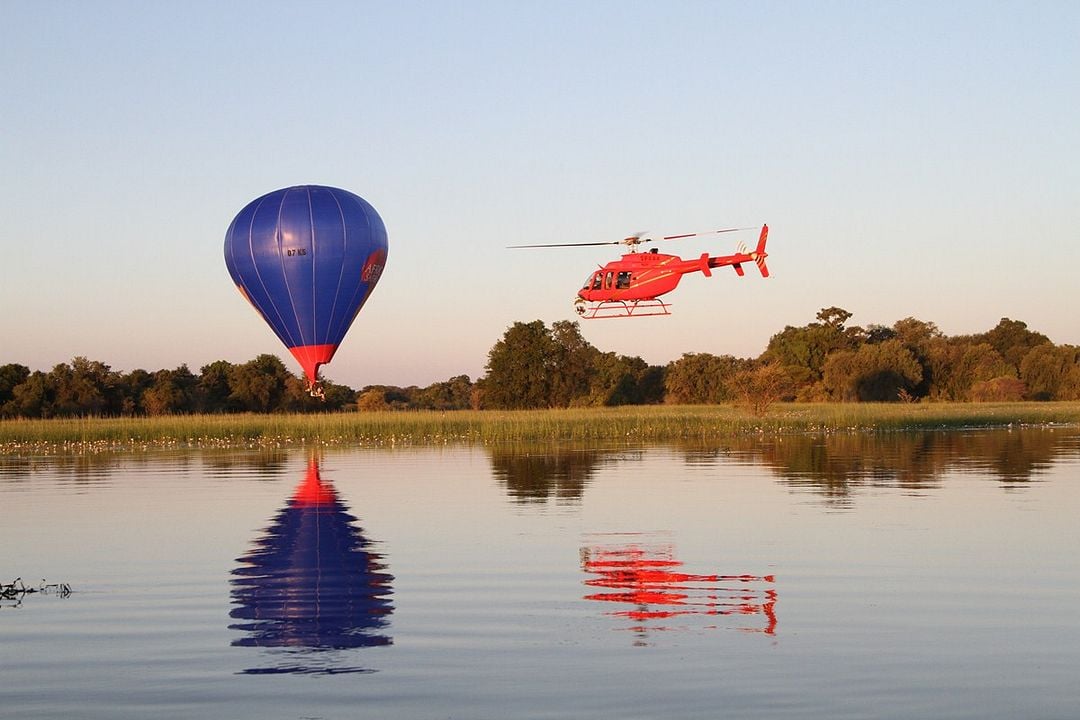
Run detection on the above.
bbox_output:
[581,536,777,639]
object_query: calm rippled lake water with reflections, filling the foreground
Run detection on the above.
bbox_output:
[0,429,1080,720]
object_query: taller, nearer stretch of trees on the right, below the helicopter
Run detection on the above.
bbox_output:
[468,307,1080,412]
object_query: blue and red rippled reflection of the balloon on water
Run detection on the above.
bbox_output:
[229,460,393,674]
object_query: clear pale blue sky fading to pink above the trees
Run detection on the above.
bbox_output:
[0,0,1080,388]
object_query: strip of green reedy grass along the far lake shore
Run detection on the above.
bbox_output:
[0,402,1080,456]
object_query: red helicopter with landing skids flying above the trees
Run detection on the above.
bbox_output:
[510,225,769,320]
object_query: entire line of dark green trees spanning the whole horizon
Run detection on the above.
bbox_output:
[0,308,1080,418]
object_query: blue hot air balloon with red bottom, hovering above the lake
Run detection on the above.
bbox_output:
[225,185,388,396]
